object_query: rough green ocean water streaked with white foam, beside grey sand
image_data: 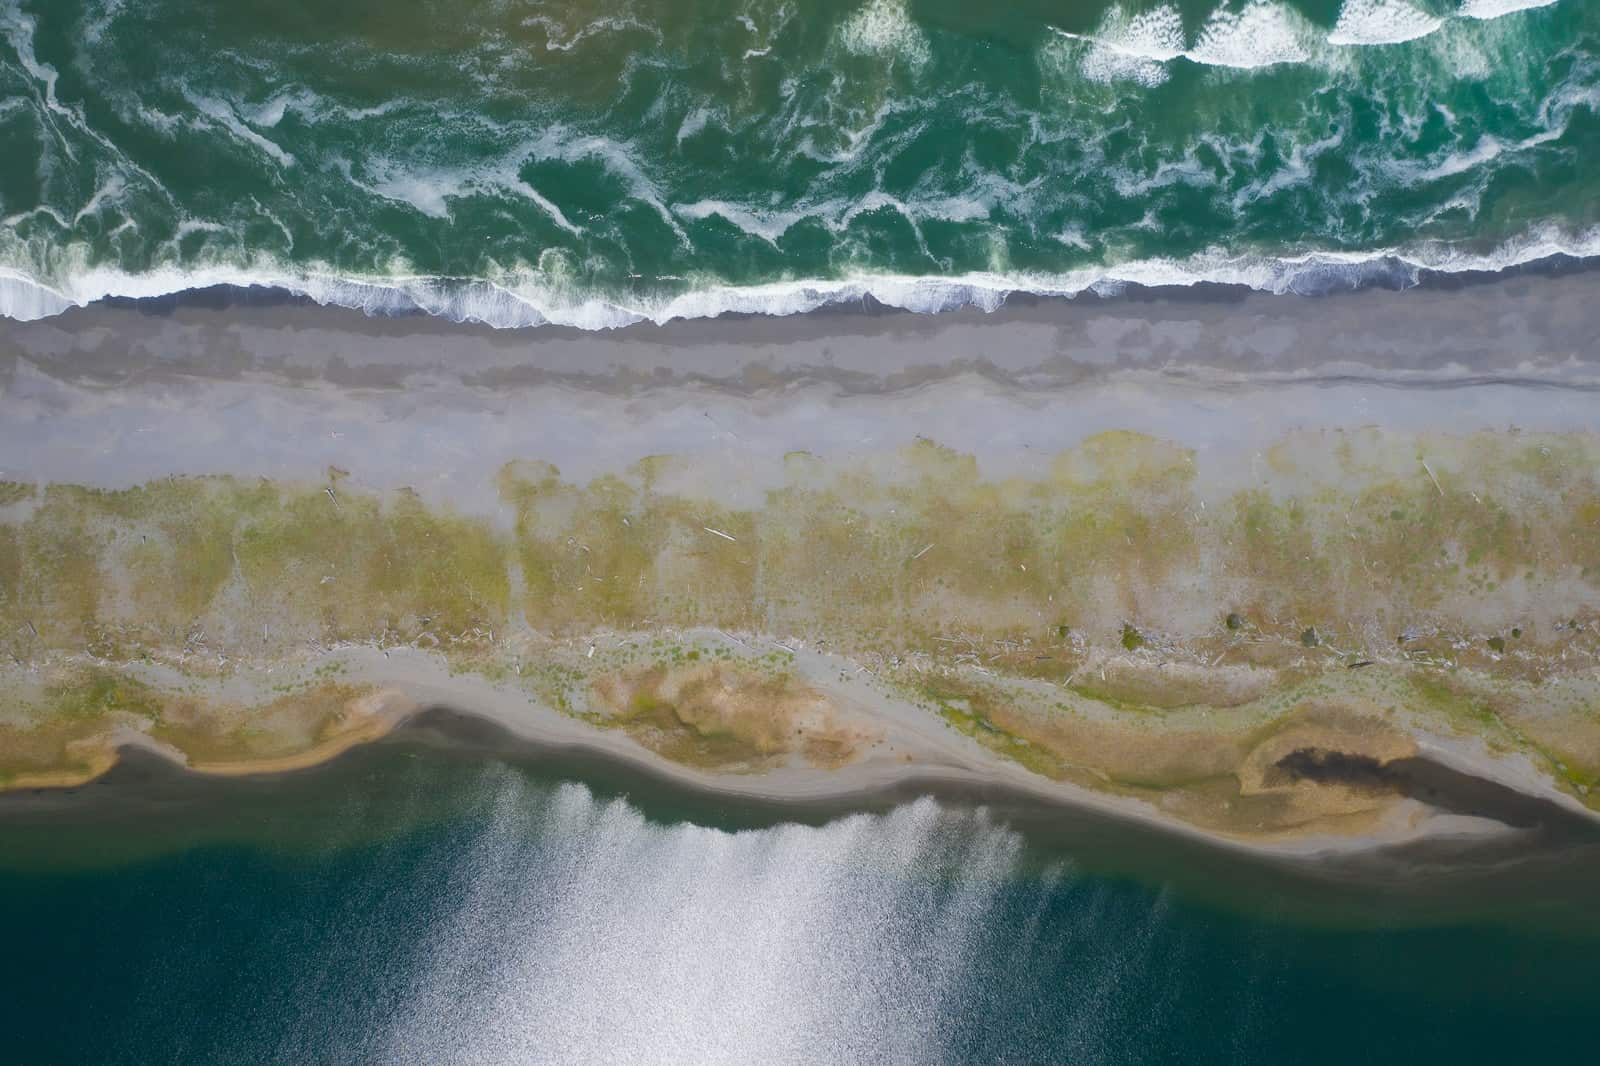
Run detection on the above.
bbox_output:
[0,0,1600,328]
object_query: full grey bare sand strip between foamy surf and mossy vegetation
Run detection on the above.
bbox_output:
[9,274,1600,514]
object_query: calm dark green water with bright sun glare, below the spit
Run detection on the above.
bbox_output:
[0,749,1600,1064]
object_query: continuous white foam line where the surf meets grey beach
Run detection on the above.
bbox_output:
[0,220,1600,330]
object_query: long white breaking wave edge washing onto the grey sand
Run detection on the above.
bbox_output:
[0,238,1600,331]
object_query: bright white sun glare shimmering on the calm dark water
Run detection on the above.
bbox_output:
[381,779,1019,1063]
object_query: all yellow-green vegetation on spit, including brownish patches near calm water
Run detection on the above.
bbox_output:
[0,431,1600,807]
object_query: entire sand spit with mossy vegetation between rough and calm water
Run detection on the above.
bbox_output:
[0,284,1600,852]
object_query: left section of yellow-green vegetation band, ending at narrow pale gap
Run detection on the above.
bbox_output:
[0,477,509,650]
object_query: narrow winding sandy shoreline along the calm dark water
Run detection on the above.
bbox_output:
[0,656,1600,879]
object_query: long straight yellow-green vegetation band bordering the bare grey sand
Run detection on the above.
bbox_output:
[12,432,1600,677]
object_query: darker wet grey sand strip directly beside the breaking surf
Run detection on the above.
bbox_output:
[9,271,1600,392]
